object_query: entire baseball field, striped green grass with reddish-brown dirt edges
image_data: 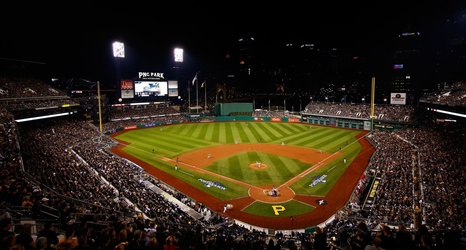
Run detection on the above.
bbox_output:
[112,121,374,230]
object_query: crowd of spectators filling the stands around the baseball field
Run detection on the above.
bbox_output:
[0,75,466,250]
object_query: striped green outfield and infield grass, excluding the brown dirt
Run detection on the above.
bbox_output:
[116,122,361,200]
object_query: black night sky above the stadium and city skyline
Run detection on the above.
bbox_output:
[0,1,465,88]
